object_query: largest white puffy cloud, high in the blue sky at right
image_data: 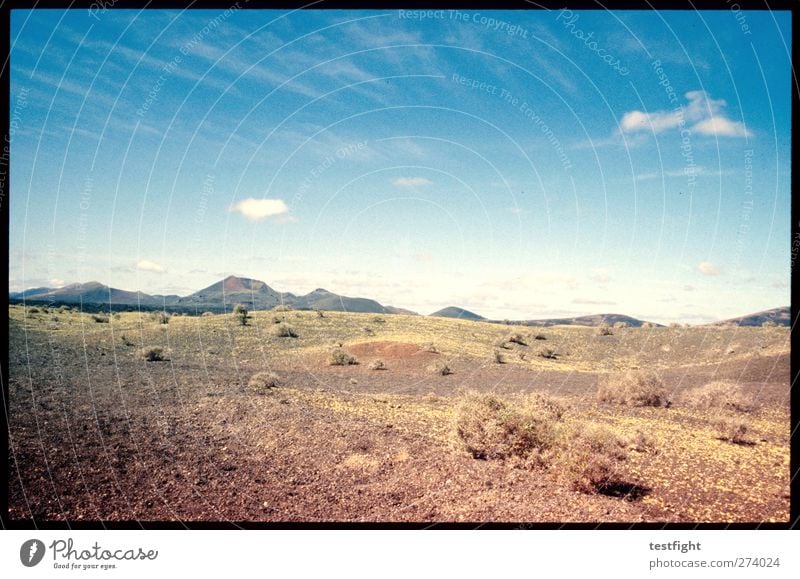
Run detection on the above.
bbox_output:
[620,90,753,137]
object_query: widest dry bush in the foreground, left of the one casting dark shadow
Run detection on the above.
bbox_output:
[451,392,564,462]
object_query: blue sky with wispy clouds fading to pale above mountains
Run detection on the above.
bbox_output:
[9,5,792,323]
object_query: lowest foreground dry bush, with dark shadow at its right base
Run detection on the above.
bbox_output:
[554,424,628,493]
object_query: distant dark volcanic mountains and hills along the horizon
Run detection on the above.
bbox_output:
[8,275,791,327]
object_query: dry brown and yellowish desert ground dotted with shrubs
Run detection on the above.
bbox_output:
[7,306,790,524]
